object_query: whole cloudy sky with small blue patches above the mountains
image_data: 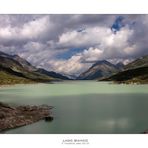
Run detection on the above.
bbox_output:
[0,14,148,75]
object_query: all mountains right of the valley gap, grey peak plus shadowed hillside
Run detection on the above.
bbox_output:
[77,55,148,84]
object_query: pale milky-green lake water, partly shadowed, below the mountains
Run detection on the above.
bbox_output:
[0,81,148,134]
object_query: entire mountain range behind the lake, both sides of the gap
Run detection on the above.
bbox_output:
[0,51,148,84]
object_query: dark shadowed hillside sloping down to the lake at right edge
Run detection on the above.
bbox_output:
[102,56,148,84]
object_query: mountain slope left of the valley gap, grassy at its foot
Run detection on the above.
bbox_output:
[0,52,69,84]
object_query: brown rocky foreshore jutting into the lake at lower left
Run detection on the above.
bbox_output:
[0,102,53,131]
